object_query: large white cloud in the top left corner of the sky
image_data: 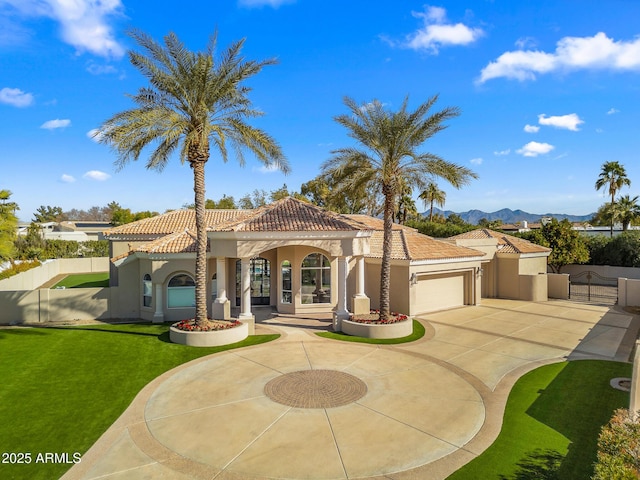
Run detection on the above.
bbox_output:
[2,0,125,58]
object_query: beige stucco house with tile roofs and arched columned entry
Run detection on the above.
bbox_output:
[104,197,549,321]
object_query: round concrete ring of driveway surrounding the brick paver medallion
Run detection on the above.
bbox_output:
[144,337,485,479]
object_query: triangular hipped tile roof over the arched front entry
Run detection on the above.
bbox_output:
[210,197,367,232]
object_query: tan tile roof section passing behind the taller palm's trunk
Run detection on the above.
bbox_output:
[104,209,246,238]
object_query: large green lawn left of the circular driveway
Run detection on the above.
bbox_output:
[0,324,278,480]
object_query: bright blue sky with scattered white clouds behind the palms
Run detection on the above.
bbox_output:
[0,0,640,220]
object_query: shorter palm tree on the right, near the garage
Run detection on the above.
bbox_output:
[322,95,477,320]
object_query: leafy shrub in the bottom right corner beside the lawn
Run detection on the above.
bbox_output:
[591,408,640,480]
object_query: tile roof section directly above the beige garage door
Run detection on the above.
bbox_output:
[368,229,485,260]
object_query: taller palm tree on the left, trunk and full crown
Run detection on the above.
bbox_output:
[96,31,289,326]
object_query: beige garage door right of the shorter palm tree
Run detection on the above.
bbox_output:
[413,273,464,312]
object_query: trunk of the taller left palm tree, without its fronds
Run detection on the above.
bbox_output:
[191,159,207,326]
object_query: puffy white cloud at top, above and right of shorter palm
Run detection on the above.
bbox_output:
[405,6,484,54]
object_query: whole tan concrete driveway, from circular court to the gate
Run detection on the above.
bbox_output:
[63,299,639,480]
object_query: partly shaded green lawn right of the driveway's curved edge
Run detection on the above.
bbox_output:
[447,360,632,480]
